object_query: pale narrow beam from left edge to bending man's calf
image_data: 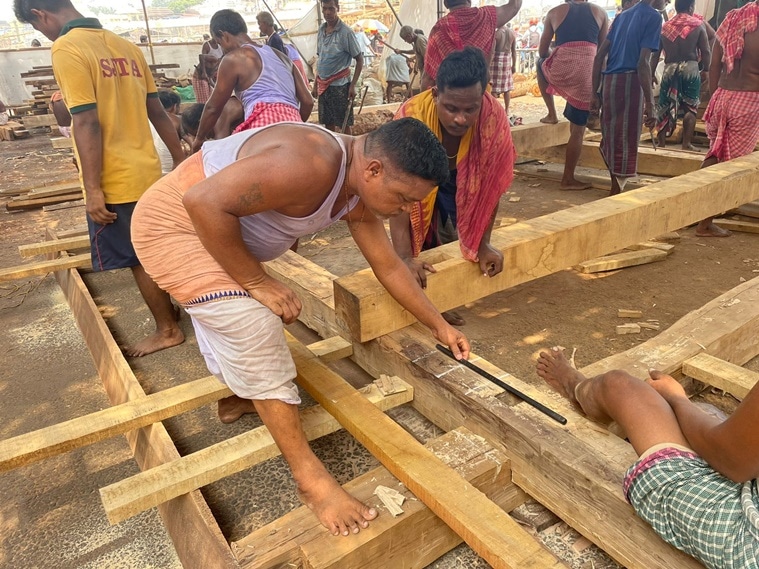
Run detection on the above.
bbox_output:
[0,376,232,472]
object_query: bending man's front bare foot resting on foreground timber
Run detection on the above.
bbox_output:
[296,470,377,536]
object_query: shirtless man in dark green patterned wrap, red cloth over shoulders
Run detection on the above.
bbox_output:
[651,0,712,150]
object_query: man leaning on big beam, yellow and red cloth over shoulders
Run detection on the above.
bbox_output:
[390,47,516,325]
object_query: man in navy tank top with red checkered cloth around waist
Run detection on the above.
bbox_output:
[537,0,609,190]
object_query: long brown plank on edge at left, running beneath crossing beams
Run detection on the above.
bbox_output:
[48,232,237,569]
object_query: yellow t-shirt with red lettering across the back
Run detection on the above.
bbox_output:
[51,18,161,204]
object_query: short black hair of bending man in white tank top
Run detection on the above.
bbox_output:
[364,117,449,186]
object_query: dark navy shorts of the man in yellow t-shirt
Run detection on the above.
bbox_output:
[87,202,140,271]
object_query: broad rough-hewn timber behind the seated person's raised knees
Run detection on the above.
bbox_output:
[580,277,759,379]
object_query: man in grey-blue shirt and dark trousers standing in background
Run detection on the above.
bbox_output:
[313,0,364,134]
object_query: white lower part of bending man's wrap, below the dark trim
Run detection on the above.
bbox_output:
[185,297,300,405]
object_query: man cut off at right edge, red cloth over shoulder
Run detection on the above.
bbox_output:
[696,2,759,237]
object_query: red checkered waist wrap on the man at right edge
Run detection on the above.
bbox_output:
[704,87,759,162]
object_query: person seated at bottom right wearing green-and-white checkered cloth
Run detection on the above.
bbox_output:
[537,348,759,569]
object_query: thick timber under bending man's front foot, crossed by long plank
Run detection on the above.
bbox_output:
[232,428,526,569]
